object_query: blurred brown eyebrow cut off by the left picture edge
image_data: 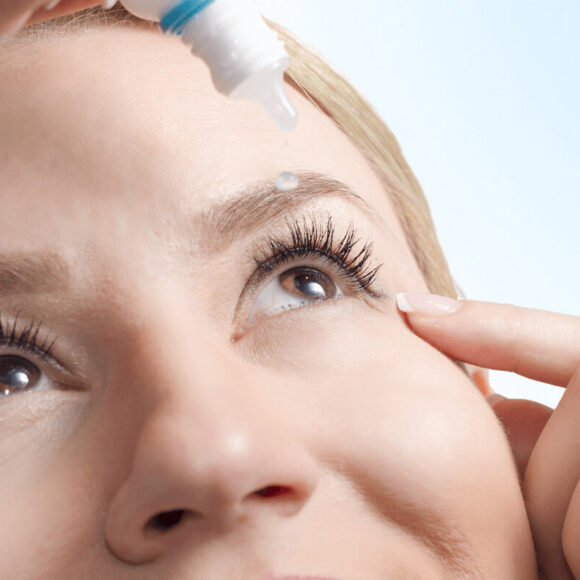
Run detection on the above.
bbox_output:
[0,252,70,296]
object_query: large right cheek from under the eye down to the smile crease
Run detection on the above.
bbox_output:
[246,301,520,541]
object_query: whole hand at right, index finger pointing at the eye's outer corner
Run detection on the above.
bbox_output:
[397,294,580,580]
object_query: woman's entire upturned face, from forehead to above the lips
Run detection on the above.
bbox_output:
[0,28,535,580]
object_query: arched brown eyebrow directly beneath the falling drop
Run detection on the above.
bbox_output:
[194,172,390,255]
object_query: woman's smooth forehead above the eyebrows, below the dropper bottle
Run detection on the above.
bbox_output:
[0,27,416,270]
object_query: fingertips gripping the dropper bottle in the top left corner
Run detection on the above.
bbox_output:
[0,0,101,35]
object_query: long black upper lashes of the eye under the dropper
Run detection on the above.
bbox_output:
[253,216,383,299]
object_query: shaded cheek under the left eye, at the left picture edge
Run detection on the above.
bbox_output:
[0,391,97,578]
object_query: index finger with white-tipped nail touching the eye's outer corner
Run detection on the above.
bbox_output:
[397,293,580,387]
